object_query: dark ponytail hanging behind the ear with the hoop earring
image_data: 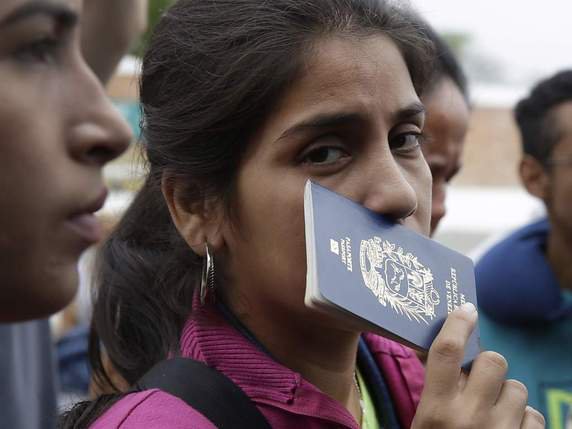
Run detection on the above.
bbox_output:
[90,175,201,385]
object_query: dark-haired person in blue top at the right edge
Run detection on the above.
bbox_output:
[476,70,572,429]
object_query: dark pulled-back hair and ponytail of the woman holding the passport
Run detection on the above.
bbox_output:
[60,0,433,427]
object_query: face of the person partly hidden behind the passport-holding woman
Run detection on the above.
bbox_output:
[423,77,470,234]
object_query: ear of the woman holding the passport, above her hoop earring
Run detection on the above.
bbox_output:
[161,175,224,256]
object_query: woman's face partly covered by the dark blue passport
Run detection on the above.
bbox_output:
[215,35,431,337]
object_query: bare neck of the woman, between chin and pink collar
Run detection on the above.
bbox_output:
[229,294,362,422]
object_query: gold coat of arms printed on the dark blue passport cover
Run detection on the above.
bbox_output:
[359,237,440,324]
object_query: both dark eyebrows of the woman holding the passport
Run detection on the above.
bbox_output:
[277,102,425,141]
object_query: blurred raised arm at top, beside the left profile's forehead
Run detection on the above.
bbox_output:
[81,0,148,83]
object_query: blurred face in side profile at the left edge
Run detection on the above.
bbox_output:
[0,0,131,322]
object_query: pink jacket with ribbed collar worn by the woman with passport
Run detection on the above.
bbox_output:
[91,305,424,429]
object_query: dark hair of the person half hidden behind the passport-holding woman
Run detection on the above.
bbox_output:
[420,22,470,105]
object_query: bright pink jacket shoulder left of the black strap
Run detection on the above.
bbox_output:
[91,389,215,429]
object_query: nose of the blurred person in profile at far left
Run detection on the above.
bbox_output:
[68,66,133,167]
